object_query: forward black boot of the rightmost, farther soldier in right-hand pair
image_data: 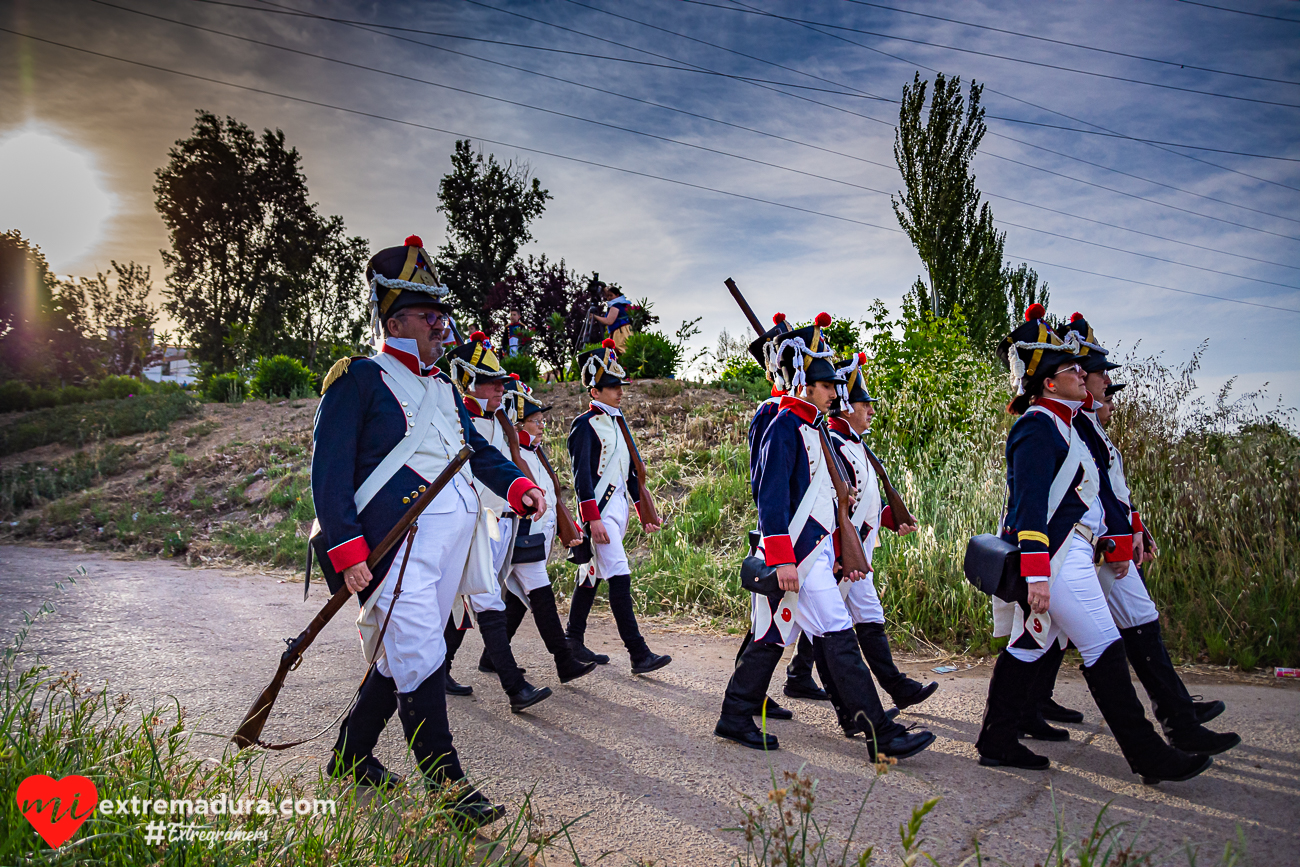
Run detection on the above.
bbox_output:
[1119,620,1242,755]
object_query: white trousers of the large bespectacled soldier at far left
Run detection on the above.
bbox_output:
[374,510,478,693]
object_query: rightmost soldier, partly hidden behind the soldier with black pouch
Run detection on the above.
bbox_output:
[1021,313,1242,755]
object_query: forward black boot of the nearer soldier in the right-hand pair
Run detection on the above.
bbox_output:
[1082,640,1214,785]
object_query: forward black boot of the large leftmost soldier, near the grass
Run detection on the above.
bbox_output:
[397,666,506,825]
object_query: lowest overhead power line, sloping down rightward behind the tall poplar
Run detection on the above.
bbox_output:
[0,26,1300,313]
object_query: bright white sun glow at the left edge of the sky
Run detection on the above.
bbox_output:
[0,125,113,272]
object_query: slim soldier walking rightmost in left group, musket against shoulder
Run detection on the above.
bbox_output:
[568,338,672,675]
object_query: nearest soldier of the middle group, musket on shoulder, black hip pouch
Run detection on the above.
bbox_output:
[714,313,935,759]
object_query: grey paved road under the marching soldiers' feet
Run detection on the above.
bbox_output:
[0,547,1300,864]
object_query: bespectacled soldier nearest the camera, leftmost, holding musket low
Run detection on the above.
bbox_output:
[312,235,546,824]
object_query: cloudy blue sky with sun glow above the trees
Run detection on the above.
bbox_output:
[0,0,1300,406]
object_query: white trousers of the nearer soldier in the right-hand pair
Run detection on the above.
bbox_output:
[1009,533,1119,666]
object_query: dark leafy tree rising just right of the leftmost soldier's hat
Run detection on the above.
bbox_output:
[437,140,551,330]
